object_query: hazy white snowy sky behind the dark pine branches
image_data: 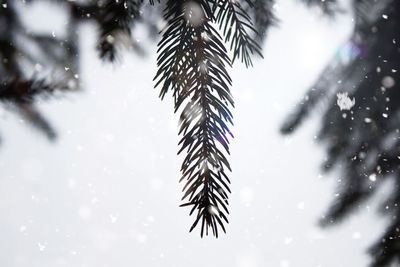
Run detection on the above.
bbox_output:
[0,0,390,267]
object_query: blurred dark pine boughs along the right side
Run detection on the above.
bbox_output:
[282,0,400,267]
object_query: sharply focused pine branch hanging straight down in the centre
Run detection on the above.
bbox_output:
[155,1,238,237]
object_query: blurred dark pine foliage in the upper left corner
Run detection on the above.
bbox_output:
[0,0,153,140]
